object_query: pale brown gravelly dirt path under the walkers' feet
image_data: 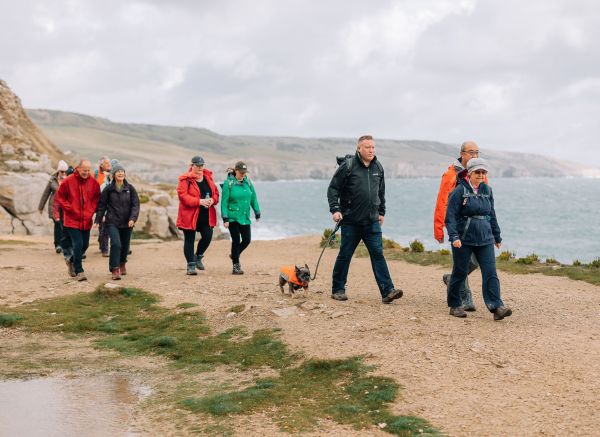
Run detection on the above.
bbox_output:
[0,237,600,436]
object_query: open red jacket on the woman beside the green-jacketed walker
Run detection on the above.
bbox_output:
[177,167,219,230]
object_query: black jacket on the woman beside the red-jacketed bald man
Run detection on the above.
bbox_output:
[96,180,140,229]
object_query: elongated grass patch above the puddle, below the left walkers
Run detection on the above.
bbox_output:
[0,286,294,368]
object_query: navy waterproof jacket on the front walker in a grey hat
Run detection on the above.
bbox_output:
[446,179,502,246]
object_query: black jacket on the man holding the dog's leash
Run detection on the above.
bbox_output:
[327,152,385,224]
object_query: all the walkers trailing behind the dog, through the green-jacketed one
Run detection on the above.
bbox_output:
[39,156,260,281]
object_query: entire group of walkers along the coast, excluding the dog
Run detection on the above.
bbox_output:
[40,135,512,320]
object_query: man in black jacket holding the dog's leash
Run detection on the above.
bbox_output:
[327,135,402,304]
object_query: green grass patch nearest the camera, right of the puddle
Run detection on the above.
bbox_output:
[181,357,440,436]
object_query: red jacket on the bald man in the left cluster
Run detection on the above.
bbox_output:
[55,171,100,231]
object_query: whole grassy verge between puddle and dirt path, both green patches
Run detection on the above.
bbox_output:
[0,286,439,436]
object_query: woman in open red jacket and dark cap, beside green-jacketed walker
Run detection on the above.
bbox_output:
[177,156,219,275]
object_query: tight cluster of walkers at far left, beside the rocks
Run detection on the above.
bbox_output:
[39,157,140,281]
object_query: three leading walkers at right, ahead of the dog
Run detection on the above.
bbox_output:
[327,135,512,320]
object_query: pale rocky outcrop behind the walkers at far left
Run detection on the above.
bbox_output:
[0,80,186,239]
